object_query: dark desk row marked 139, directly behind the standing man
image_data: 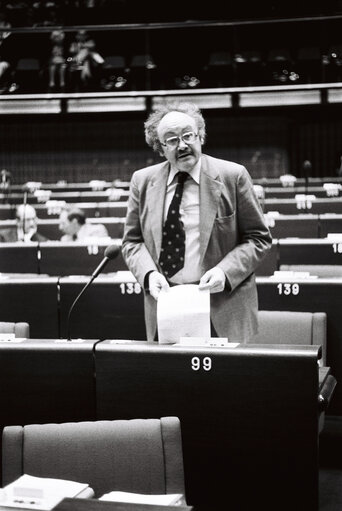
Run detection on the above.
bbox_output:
[0,272,342,415]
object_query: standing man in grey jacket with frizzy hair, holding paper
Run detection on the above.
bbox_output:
[122,103,272,341]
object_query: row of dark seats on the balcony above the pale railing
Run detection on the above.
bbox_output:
[4,43,342,92]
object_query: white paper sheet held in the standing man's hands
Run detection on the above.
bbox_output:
[157,284,210,344]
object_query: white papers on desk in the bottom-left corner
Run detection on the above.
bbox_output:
[0,474,94,511]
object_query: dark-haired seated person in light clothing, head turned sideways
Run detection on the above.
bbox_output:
[59,208,109,241]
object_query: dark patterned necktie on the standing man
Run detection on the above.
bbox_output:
[159,172,189,278]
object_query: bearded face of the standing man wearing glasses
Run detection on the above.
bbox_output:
[157,112,202,172]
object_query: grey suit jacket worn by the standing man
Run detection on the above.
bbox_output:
[122,154,272,341]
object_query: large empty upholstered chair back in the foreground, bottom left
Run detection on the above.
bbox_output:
[2,417,185,497]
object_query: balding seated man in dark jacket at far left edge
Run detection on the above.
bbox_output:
[0,204,48,242]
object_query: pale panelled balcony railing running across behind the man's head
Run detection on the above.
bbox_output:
[0,82,342,114]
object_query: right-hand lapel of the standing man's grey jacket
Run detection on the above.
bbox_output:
[200,155,223,263]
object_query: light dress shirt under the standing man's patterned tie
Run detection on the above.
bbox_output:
[164,160,202,284]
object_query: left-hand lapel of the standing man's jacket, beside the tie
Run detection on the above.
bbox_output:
[146,162,169,259]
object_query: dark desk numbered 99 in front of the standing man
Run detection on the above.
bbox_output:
[95,341,319,511]
